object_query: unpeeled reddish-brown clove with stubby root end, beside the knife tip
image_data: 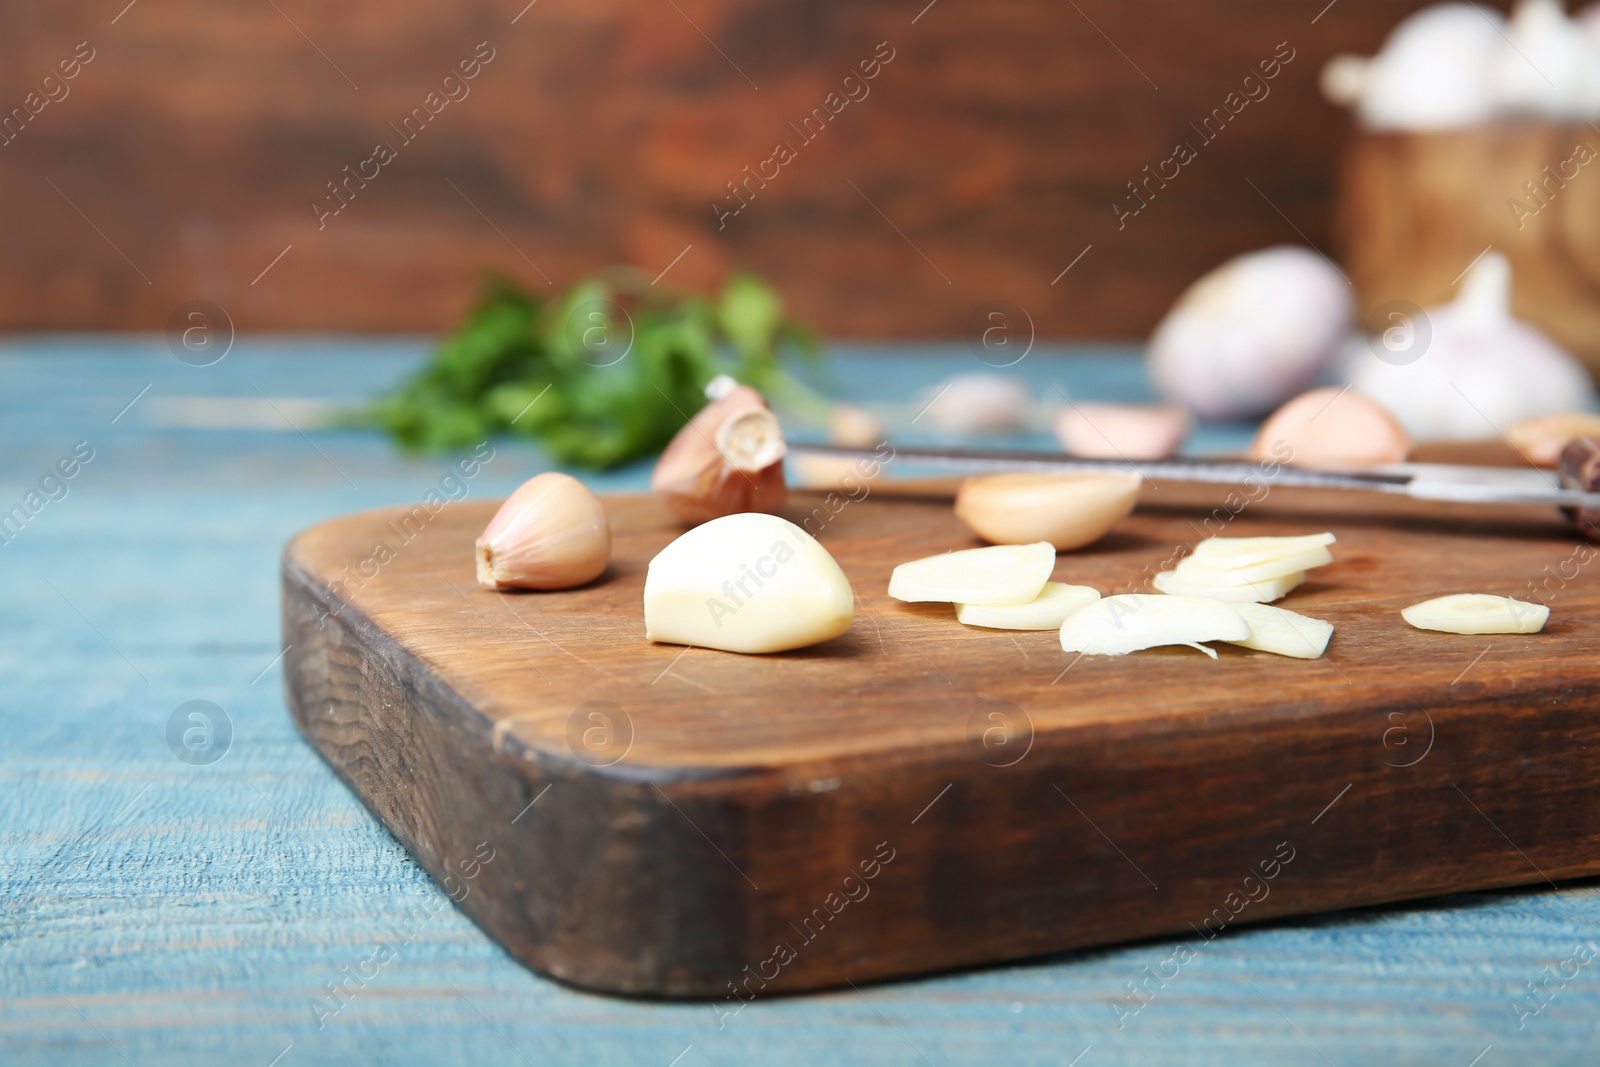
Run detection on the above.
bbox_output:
[650,386,789,525]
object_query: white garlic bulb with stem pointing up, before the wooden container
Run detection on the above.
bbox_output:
[1346,253,1594,440]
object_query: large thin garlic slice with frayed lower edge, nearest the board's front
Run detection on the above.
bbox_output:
[1061,593,1250,659]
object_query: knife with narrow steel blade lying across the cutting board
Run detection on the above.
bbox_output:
[789,438,1600,515]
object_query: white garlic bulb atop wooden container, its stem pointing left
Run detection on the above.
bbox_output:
[1322,3,1506,130]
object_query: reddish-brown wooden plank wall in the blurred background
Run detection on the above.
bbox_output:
[0,0,1446,338]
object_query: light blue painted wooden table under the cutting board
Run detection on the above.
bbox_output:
[0,338,1600,1067]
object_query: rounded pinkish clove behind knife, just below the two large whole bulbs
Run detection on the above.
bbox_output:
[1245,387,1411,469]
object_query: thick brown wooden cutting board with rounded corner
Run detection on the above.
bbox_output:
[283,486,1600,1013]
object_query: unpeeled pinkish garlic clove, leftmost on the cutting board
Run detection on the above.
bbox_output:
[475,470,611,589]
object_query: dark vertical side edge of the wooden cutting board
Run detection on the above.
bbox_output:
[283,521,1600,1011]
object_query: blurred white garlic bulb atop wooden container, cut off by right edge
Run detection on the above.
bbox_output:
[1491,0,1600,122]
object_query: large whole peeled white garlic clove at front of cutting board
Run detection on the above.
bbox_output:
[645,512,856,653]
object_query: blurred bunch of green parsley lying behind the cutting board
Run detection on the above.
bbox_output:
[362,269,824,469]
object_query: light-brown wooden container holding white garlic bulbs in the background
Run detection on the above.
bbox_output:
[1336,123,1600,378]
